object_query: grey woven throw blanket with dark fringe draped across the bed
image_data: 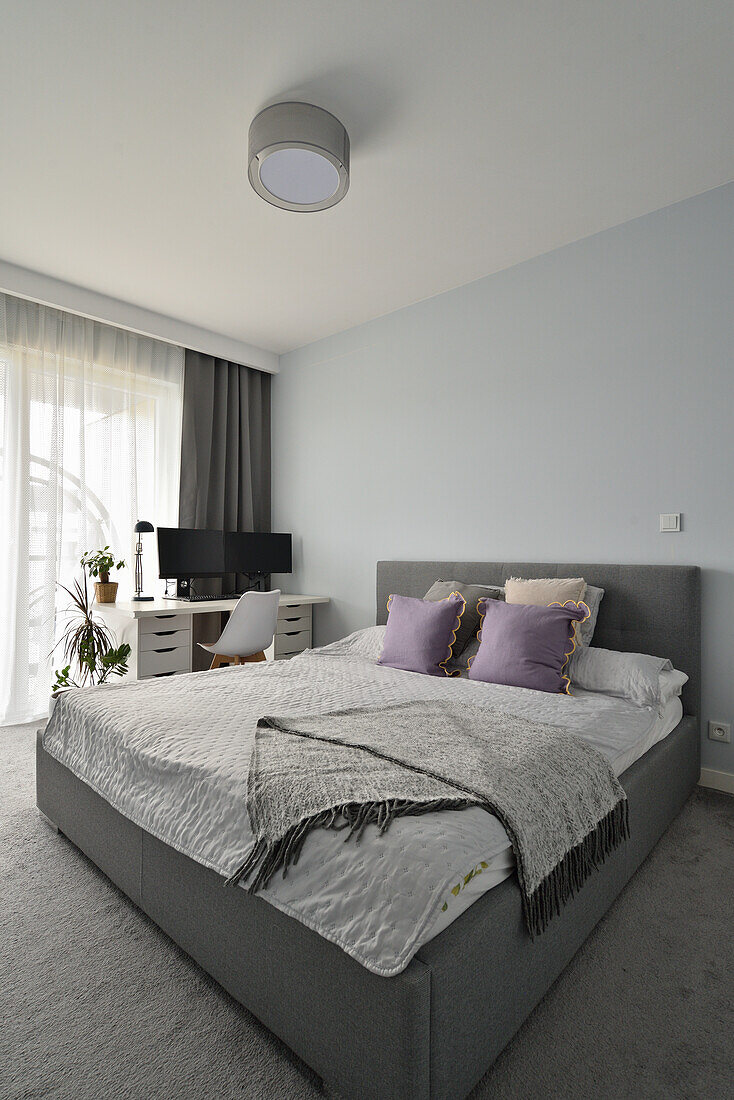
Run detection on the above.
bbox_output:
[228,702,628,936]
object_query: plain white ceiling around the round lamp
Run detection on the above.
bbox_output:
[0,0,734,352]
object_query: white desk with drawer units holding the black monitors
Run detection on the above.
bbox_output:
[95,594,329,680]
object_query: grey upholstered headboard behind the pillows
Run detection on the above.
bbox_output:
[377,561,701,716]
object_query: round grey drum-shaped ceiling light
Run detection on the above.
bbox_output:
[248,102,349,211]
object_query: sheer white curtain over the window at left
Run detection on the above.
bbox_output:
[0,294,184,724]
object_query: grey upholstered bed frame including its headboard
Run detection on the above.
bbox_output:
[36,561,701,1100]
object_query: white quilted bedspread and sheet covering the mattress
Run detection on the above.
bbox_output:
[44,627,680,976]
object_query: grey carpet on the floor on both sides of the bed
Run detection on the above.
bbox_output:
[0,726,734,1100]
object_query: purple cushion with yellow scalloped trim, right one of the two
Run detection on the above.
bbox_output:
[469,600,589,694]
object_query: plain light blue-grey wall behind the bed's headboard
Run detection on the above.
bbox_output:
[273,185,734,772]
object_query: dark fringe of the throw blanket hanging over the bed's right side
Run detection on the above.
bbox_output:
[518,798,629,939]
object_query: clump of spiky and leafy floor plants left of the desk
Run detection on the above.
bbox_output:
[52,572,131,695]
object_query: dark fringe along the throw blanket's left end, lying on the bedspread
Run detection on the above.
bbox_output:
[224,799,479,893]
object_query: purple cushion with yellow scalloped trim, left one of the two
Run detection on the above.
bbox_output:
[377,592,465,677]
